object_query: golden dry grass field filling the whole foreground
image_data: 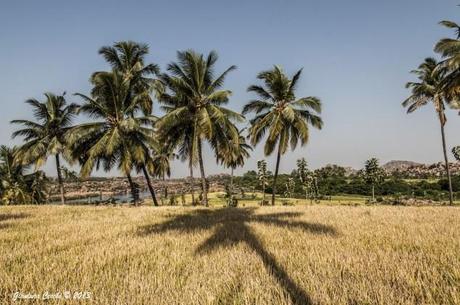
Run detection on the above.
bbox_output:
[0,201,460,305]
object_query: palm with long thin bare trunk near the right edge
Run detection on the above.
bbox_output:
[402,58,453,204]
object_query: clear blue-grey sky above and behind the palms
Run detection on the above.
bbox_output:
[0,0,460,176]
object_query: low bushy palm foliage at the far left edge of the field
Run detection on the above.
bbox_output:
[0,145,49,204]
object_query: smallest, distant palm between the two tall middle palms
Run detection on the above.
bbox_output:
[217,128,252,195]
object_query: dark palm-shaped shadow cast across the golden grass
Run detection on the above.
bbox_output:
[139,208,337,305]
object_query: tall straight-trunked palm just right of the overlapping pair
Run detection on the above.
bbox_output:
[157,50,243,206]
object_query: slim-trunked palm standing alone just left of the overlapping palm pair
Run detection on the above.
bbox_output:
[11,93,78,204]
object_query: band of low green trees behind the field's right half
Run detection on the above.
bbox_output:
[235,165,460,201]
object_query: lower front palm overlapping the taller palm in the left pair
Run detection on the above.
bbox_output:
[68,71,155,203]
